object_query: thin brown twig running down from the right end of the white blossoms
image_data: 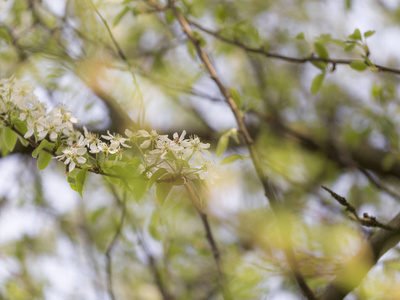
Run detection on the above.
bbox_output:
[185,182,233,300]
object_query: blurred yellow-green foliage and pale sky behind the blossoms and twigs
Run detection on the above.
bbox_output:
[0,0,400,300]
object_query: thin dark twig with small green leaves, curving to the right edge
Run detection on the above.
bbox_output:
[188,20,400,75]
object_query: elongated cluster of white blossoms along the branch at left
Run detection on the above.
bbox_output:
[0,78,217,181]
